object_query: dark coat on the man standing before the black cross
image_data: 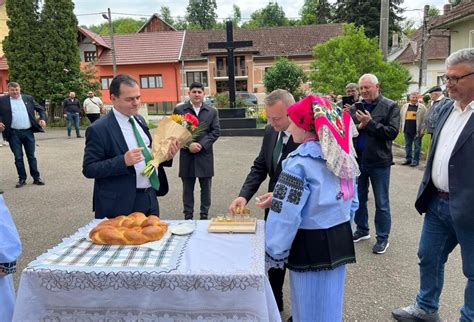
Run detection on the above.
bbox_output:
[173,102,220,178]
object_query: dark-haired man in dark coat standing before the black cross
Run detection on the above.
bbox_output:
[173,82,220,219]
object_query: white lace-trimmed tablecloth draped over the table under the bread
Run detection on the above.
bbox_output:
[14,221,280,322]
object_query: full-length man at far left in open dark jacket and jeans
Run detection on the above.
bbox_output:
[0,82,46,188]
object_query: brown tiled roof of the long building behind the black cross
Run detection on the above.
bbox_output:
[181,24,342,61]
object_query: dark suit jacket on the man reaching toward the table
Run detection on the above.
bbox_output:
[239,125,299,202]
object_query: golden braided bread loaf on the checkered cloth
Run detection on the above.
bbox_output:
[89,212,168,245]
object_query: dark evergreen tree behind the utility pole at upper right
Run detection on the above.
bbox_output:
[334,0,404,38]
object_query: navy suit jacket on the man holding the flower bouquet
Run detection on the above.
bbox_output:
[82,111,171,218]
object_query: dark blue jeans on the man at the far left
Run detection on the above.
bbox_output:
[9,129,40,180]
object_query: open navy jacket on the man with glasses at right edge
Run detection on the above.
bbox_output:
[415,101,474,230]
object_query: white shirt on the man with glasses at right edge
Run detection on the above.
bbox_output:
[431,101,474,192]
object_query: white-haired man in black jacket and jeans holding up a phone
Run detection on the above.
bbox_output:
[352,74,400,254]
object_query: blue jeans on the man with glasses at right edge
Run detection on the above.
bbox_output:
[416,196,474,321]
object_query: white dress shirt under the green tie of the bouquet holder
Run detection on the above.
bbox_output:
[112,108,151,189]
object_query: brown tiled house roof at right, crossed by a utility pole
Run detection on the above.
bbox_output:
[396,28,449,64]
